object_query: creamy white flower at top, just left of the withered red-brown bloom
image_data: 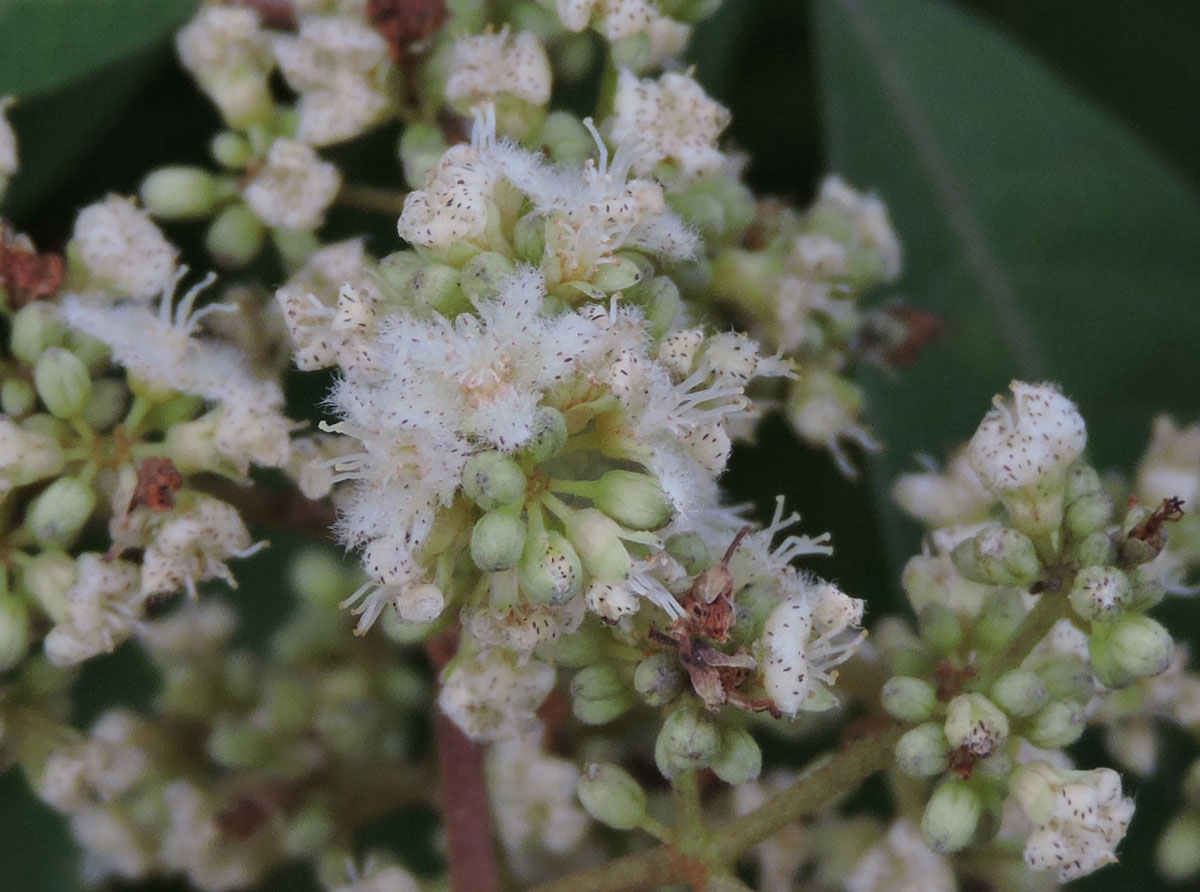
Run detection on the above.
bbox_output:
[271,16,392,145]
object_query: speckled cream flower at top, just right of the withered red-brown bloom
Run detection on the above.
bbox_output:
[446,26,551,106]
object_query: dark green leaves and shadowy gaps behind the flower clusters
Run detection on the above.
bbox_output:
[0,0,1200,892]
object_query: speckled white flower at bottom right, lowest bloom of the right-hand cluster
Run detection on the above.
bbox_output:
[1010,761,1133,882]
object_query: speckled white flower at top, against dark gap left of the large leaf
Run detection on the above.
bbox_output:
[612,68,730,182]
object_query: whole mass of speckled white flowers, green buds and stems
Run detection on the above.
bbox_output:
[0,0,1200,892]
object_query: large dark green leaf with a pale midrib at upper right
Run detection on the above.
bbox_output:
[814,0,1200,578]
